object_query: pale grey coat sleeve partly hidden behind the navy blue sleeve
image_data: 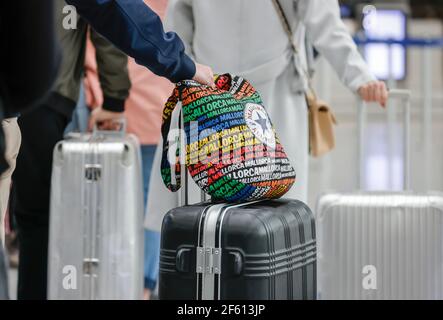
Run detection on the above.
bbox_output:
[165,0,194,57]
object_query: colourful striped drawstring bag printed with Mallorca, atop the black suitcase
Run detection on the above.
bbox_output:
[161,74,295,202]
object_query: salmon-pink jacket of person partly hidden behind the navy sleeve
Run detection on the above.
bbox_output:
[85,0,174,145]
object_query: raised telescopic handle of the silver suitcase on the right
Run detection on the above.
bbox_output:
[357,89,411,190]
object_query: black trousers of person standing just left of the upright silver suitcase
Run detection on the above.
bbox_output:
[13,106,69,300]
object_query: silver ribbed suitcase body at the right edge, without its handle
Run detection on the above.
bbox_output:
[316,192,443,300]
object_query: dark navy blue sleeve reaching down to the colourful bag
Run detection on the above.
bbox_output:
[66,0,196,82]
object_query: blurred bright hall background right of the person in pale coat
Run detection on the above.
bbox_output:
[309,0,443,208]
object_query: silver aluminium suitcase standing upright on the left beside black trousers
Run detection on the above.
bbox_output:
[48,125,143,300]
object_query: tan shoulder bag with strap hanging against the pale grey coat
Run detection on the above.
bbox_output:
[272,0,337,157]
